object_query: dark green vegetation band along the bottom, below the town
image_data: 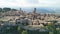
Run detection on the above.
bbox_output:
[0,22,60,34]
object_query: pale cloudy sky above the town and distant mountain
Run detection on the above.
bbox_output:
[0,0,60,8]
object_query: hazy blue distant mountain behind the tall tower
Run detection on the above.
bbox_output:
[22,8,55,13]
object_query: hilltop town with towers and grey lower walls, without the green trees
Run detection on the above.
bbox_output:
[0,8,60,32]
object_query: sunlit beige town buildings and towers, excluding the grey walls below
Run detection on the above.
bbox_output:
[0,8,60,25]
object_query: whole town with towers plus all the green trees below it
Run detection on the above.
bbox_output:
[0,8,60,34]
